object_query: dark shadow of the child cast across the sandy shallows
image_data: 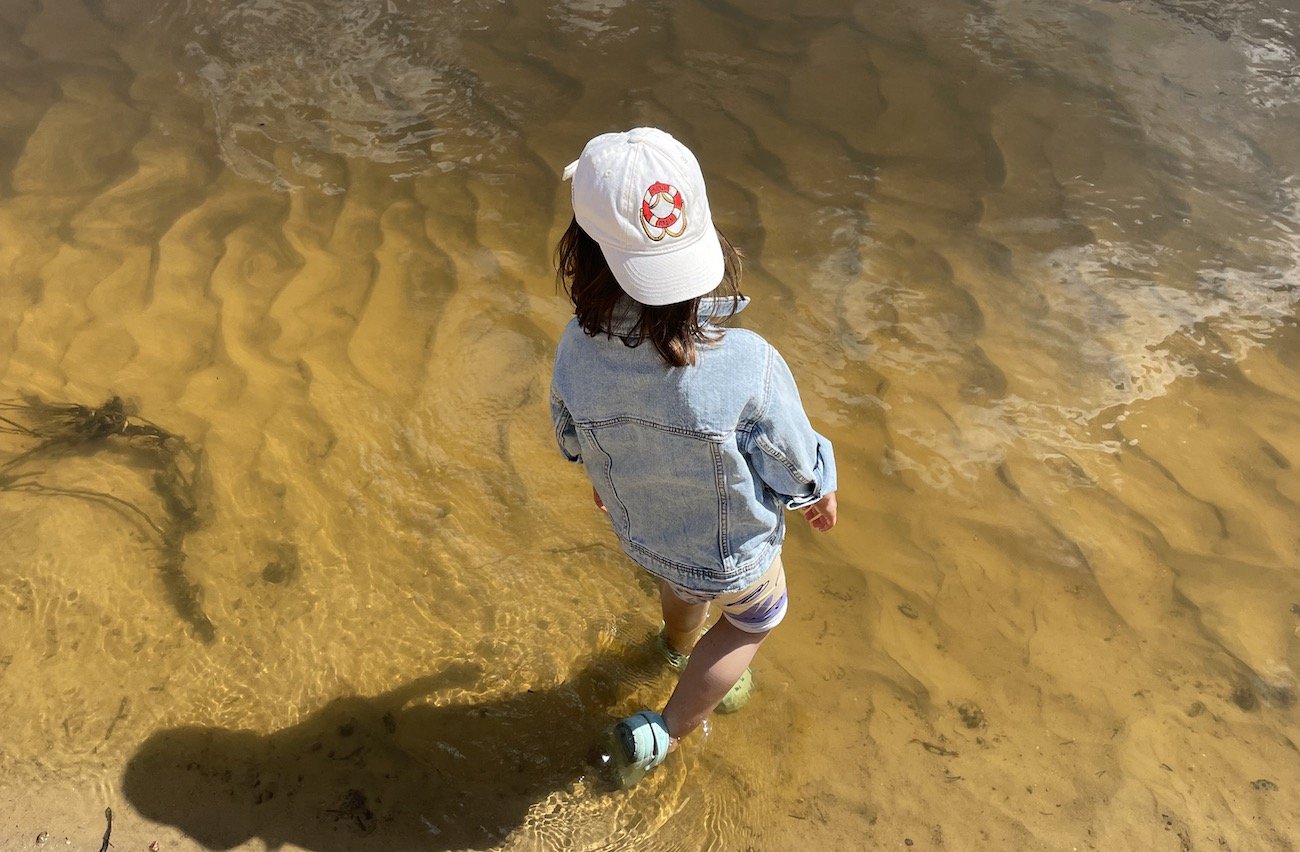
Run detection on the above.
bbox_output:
[122,640,662,852]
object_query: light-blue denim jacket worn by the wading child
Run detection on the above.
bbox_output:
[551,300,836,594]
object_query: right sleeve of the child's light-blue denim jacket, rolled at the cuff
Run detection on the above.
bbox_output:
[748,350,836,509]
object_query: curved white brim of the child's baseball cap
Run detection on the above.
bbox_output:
[601,229,725,306]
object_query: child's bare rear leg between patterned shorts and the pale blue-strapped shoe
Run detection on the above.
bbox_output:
[663,618,767,740]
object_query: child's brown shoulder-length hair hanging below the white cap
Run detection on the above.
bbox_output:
[555,219,741,367]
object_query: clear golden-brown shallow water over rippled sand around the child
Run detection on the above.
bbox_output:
[0,0,1300,851]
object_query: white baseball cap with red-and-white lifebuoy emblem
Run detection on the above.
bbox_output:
[564,127,724,304]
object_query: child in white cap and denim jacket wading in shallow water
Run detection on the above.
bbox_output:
[551,127,836,784]
